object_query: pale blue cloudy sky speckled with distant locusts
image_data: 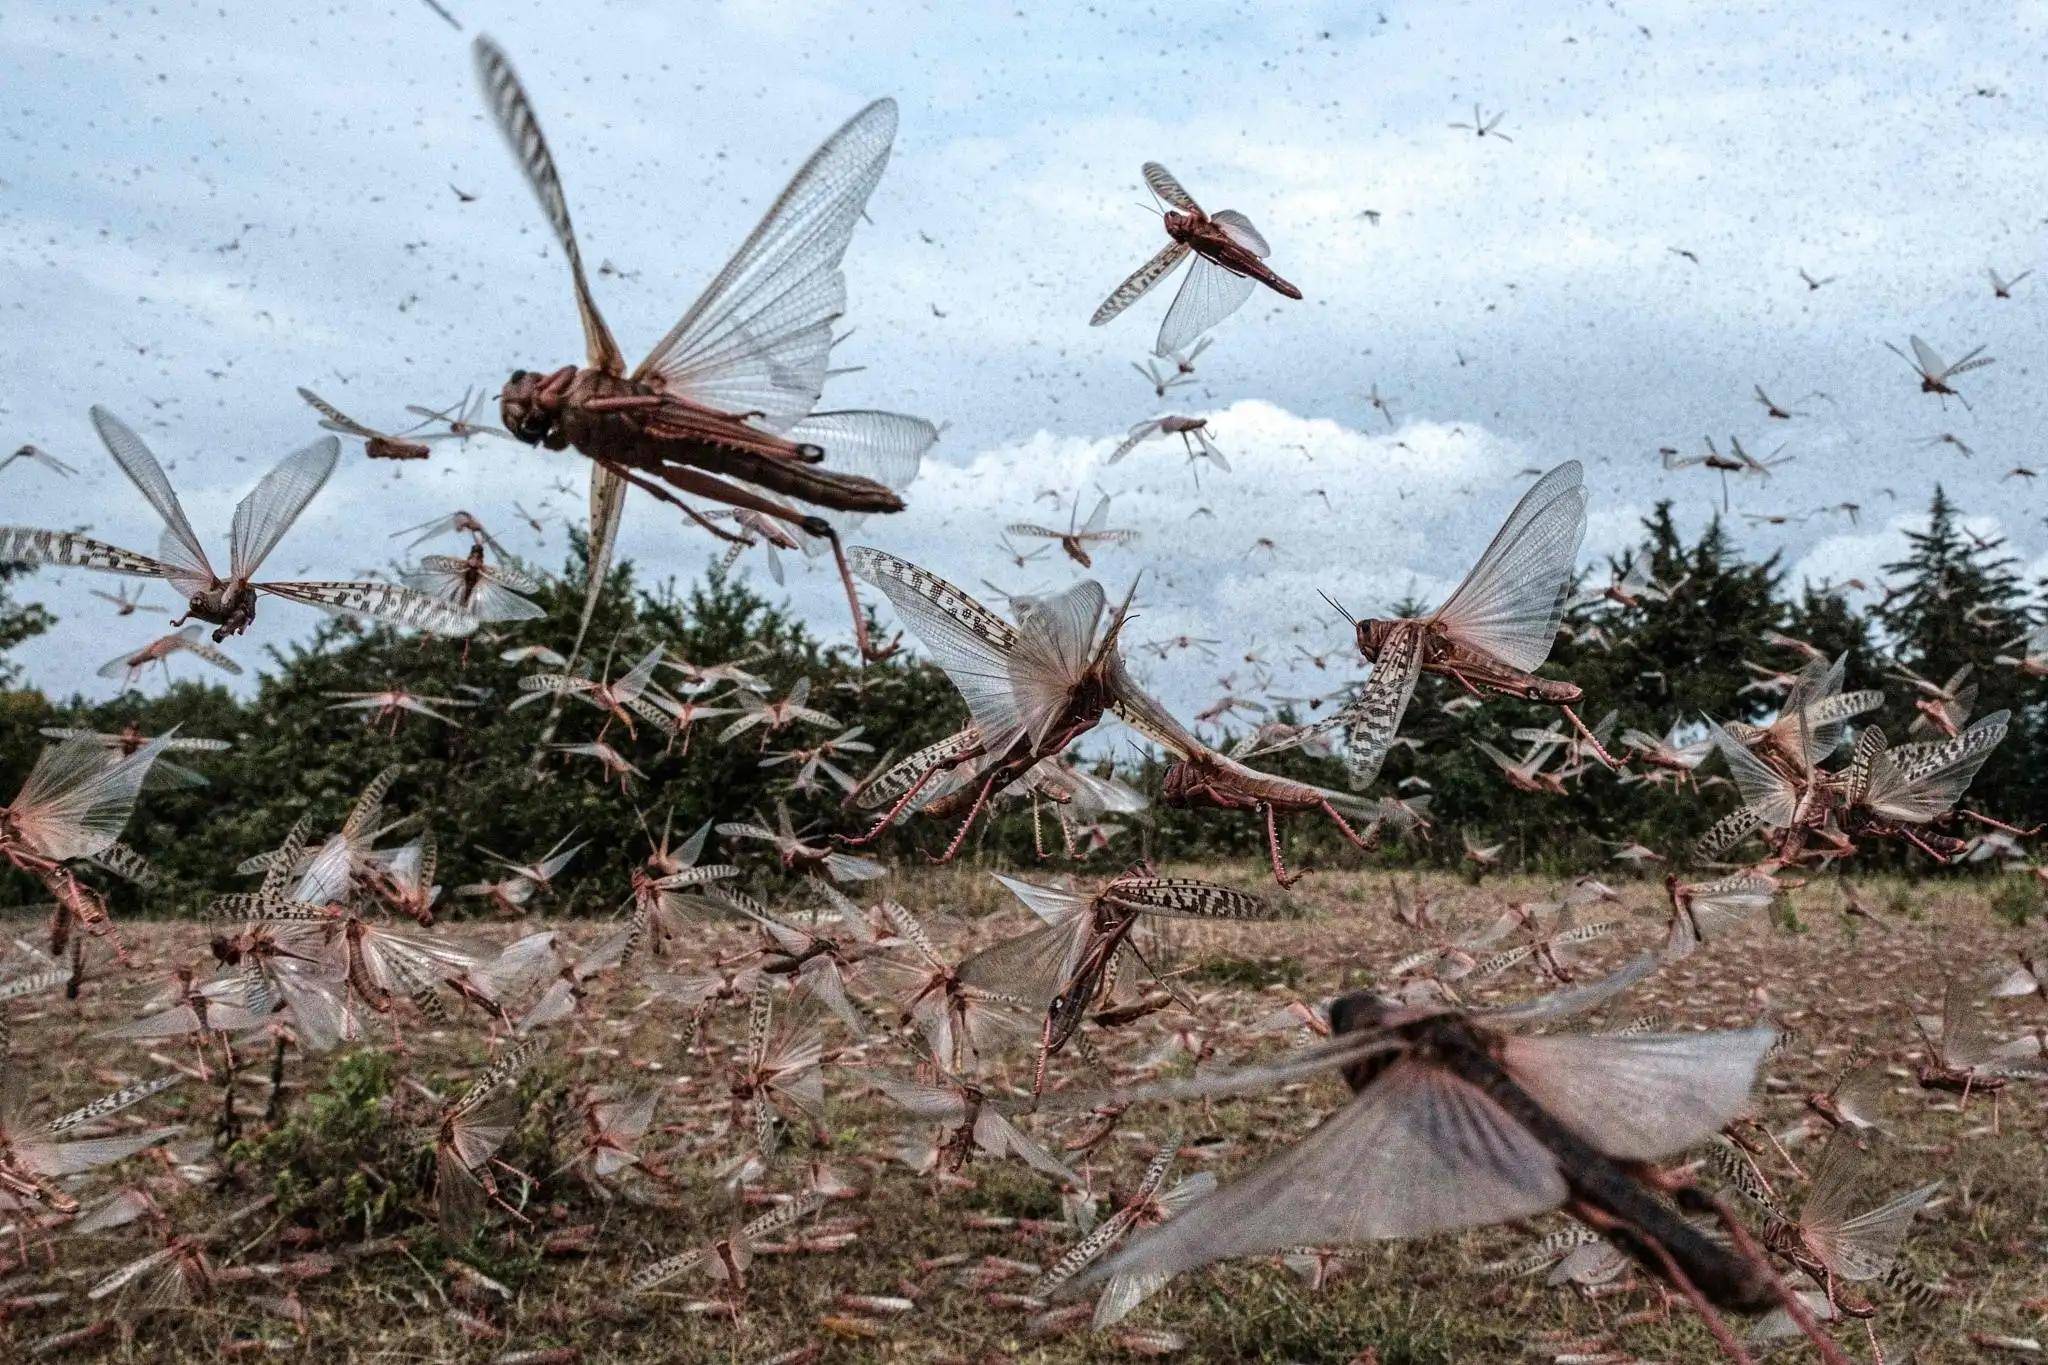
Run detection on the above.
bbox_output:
[0,0,2048,724]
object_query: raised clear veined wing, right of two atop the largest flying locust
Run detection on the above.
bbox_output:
[633,100,897,432]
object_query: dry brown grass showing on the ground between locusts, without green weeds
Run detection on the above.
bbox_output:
[0,868,2048,1365]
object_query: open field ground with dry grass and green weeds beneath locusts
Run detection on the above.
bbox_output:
[0,868,2048,1365]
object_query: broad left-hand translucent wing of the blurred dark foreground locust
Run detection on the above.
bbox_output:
[1079,1060,1567,1285]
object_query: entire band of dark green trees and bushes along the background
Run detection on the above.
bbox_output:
[0,491,2048,879]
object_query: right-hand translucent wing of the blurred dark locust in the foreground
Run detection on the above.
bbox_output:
[1501,1029,1778,1160]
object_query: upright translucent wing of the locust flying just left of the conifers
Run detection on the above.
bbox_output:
[1434,460,1585,673]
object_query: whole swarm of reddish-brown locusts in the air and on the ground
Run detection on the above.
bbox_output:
[0,29,2048,1363]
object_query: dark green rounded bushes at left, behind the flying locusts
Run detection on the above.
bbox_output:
[0,561,967,915]
